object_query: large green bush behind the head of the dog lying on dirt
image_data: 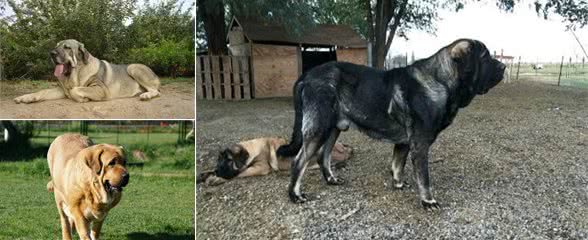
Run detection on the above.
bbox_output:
[0,0,136,78]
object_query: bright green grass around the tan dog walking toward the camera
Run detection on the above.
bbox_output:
[0,142,194,240]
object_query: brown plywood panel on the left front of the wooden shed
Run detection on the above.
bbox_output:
[251,43,300,98]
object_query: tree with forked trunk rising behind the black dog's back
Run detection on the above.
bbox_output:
[313,0,588,69]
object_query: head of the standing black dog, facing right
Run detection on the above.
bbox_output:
[449,39,506,94]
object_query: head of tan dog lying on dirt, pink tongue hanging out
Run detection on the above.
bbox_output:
[50,39,90,78]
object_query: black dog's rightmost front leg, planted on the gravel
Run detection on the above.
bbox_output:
[410,142,441,211]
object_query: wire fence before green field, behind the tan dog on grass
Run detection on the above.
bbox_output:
[0,121,194,146]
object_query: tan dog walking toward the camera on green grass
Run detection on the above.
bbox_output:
[47,134,129,240]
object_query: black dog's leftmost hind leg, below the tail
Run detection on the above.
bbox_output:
[288,138,321,203]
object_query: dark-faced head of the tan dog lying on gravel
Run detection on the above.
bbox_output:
[215,144,249,179]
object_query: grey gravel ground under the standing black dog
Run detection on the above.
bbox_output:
[197,82,588,239]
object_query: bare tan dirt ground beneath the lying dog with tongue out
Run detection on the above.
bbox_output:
[0,81,194,119]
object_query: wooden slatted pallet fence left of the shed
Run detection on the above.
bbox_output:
[196,56,253,100]
